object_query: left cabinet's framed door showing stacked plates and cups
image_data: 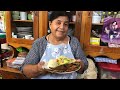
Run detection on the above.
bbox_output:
[5,11,39,48]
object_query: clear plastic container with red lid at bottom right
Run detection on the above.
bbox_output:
[98,62,120,79]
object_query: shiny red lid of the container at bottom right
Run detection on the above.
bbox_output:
[98,62,120,72]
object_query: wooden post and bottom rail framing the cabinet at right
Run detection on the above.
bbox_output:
[80,11,120,59]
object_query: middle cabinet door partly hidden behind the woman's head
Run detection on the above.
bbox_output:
[45,11,82,41]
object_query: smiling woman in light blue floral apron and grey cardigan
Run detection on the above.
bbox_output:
[21,11,88,79]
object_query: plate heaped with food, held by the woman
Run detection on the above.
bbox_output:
[45,56,81,73]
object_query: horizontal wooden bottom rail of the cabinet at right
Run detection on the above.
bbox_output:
[84,45,120,59]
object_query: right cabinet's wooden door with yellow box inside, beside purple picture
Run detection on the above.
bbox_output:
[81,11,120,59]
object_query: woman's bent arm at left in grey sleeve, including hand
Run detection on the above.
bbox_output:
[20,39,44,78]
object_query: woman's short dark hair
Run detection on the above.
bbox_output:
[49,11,71,22]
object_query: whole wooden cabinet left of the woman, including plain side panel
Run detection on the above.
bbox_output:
[5,11,47,53]
